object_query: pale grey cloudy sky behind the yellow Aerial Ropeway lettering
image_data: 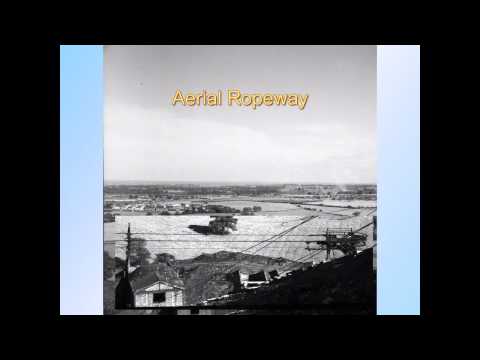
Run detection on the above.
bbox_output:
[104,45,377,183]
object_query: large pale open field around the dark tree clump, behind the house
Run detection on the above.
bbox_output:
[104,208,375,260]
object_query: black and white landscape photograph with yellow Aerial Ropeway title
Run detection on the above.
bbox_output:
[103,45,381,315]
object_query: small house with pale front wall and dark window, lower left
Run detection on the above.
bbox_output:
[130,264,185,307]
